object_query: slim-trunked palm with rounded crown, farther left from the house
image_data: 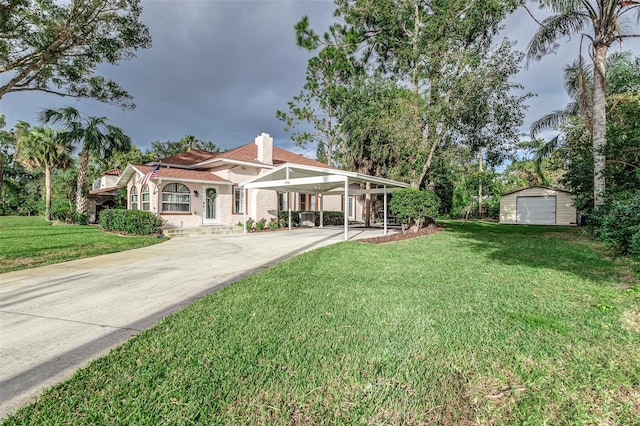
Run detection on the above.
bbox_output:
[17,123,73,220]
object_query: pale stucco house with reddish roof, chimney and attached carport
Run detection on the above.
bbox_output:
[117,133,406,235]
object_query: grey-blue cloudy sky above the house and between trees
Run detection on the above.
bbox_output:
[0,0,640,153]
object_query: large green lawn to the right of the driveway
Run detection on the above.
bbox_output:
[6,223,640,425]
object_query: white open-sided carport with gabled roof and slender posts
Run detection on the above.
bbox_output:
[242,164,409,240]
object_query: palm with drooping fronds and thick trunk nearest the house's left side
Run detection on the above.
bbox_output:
[40,107,131,214]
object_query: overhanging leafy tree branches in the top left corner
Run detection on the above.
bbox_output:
[0,0,151,108]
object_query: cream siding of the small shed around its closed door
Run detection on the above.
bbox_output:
[500,187,576,225]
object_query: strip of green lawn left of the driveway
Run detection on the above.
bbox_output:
[0,216,161,273]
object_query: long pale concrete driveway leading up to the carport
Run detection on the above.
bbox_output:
[0,229,388,418]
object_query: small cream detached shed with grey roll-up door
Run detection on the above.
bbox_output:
[500,186,576,225]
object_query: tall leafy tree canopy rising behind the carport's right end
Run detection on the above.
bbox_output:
[296,0,525,188]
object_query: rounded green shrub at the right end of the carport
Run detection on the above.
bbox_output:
[389,188,440,231]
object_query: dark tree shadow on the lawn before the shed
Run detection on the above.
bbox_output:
[446,222,615,282]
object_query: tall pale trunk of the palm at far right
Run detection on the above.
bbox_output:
[593,44,608,207]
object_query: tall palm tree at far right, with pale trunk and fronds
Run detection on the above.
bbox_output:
[523,0,640,206]
